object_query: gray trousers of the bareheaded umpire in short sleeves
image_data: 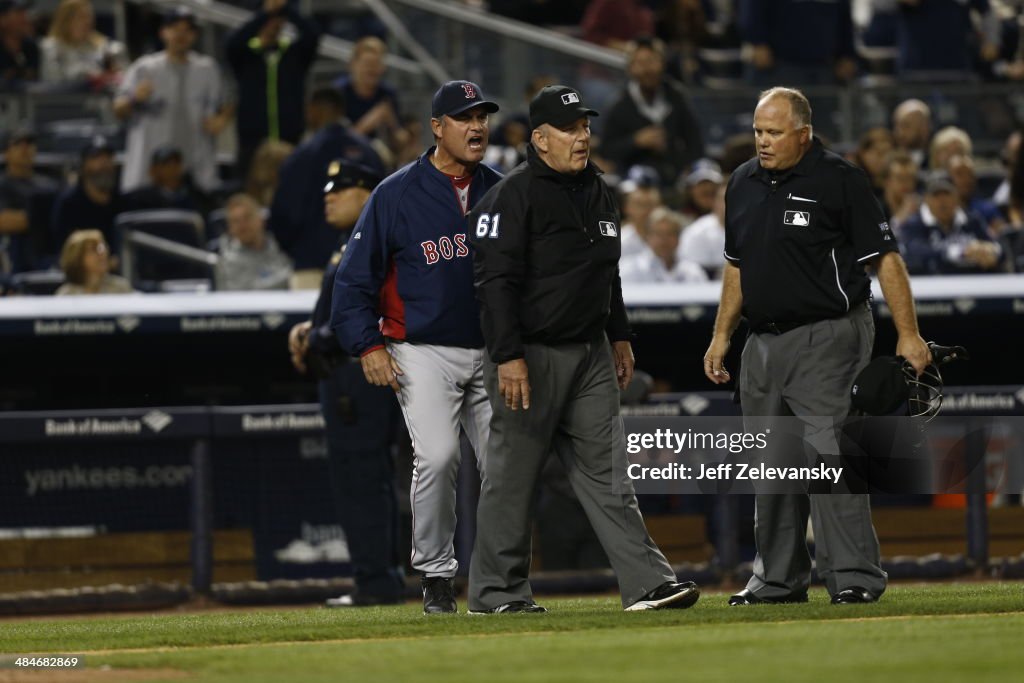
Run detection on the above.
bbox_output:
[739,304,887,599]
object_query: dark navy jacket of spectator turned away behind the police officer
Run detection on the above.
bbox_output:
[270,123,386,270]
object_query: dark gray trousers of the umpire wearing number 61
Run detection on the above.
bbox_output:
[469,336,676,610]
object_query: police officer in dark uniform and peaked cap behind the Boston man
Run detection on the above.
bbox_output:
[288,161,404,607]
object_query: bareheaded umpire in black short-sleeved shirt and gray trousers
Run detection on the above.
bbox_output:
[703,88,931,605]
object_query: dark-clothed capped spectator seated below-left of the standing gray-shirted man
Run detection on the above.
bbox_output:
[50,136,121,254]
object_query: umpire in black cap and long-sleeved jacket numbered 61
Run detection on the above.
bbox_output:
[469,85,699,613]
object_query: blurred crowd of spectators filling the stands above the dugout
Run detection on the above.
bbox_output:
[0,0,1024,292]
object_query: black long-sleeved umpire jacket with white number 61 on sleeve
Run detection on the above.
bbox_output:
[469,147,630,362]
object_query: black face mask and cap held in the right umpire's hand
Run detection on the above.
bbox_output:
[850,342,971,422]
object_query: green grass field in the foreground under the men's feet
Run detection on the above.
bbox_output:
[0,583,1024,683]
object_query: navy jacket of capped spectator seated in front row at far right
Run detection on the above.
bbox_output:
[900,206,995,275]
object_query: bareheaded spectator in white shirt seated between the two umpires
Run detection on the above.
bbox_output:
[620,207,708,283]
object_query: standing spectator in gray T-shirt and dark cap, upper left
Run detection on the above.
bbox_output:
[114,7,233,193]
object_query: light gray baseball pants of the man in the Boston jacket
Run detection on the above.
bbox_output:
[387,341,490,578]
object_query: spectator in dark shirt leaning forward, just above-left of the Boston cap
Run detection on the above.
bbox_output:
[335,36,400,141]
